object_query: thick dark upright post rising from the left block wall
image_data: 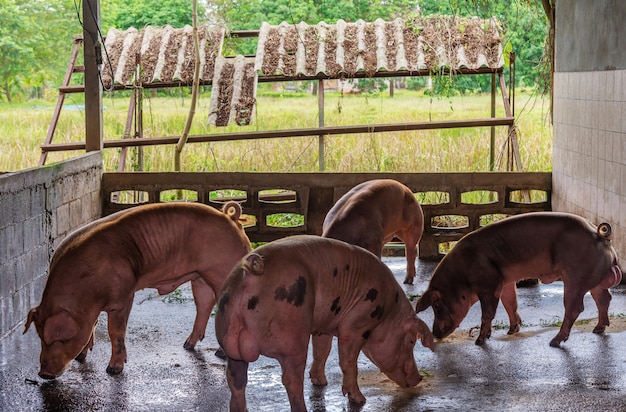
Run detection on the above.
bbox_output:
[83,0,103,152]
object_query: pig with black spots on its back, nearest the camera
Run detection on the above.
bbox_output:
[215,235,433,411]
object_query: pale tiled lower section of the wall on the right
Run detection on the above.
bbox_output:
[552,70,626,268]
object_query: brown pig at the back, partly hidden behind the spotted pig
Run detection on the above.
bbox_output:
[322,179,424,284]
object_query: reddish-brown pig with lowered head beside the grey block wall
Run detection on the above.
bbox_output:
[24,202,251,379]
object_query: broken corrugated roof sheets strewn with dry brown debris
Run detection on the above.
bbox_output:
[96,16,504,126]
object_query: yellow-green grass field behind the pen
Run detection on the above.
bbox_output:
[0,90,552,172]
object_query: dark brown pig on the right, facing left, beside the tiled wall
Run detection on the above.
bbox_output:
[416,212,622,347]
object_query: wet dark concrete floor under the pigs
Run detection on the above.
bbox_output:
[0,257,626,411]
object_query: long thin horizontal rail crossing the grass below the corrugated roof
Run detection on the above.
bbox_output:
[41,117,515,152]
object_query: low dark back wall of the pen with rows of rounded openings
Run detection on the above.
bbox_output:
[102,172,552,258]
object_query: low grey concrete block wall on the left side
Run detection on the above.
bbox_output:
[0,152,102,338]
